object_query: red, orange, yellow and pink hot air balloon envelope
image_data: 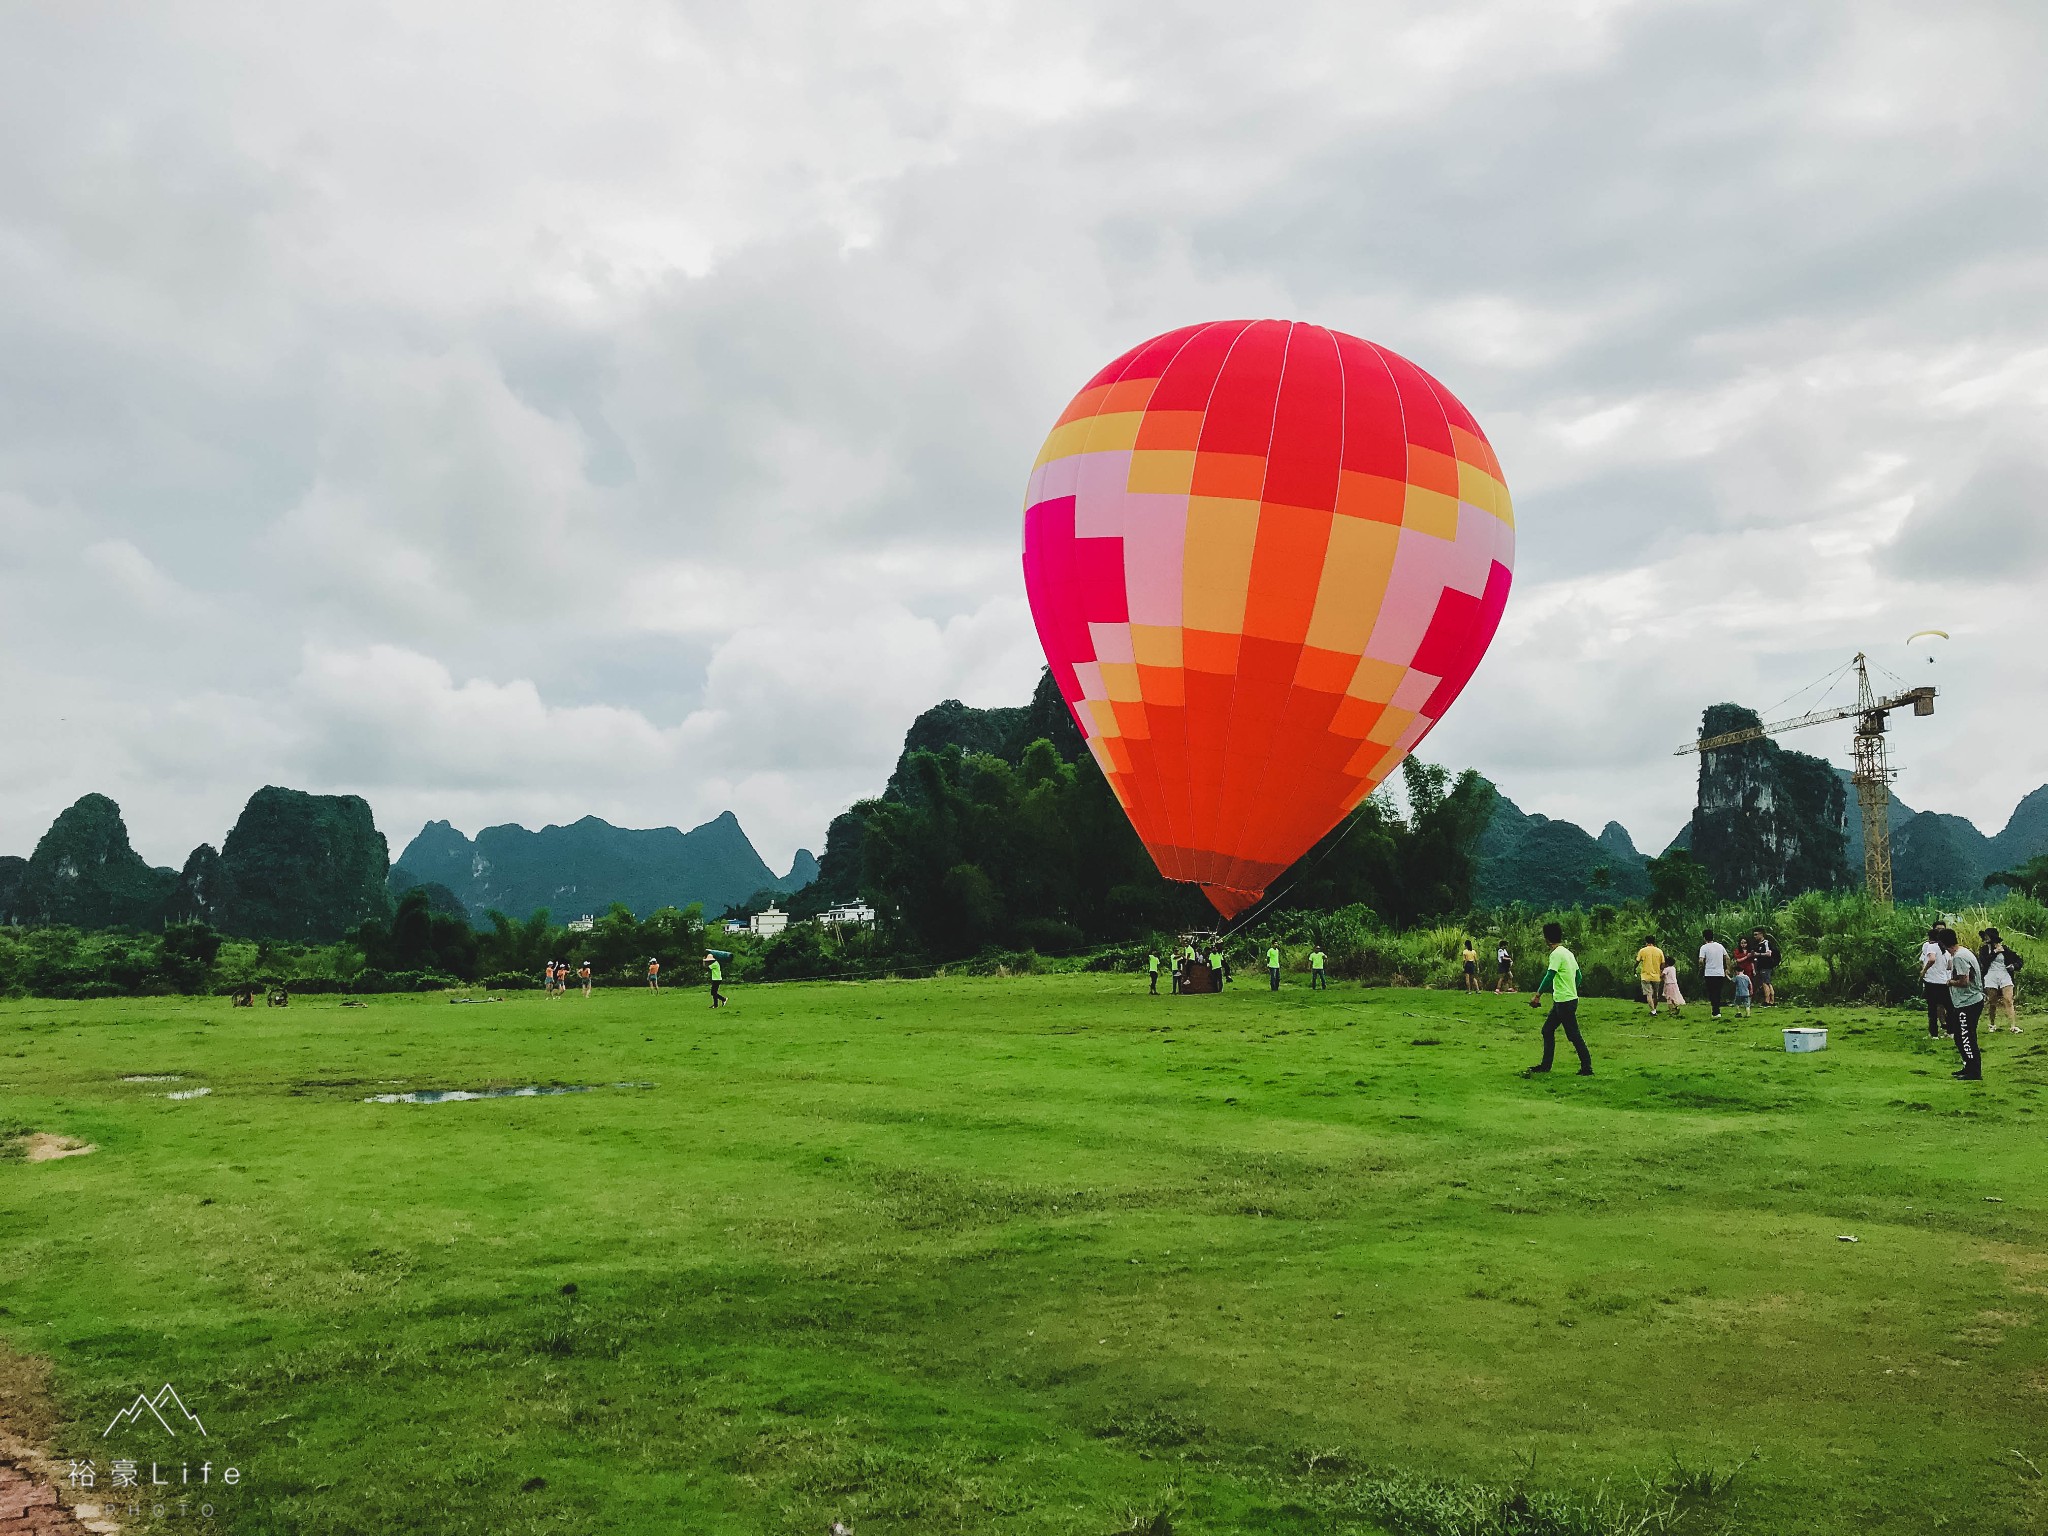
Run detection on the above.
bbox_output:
[1024,319,1516,918]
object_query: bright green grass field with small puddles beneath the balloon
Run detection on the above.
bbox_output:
[0,975,2048,1536]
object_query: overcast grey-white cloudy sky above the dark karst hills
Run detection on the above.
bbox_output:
[0,0,2048,868]
